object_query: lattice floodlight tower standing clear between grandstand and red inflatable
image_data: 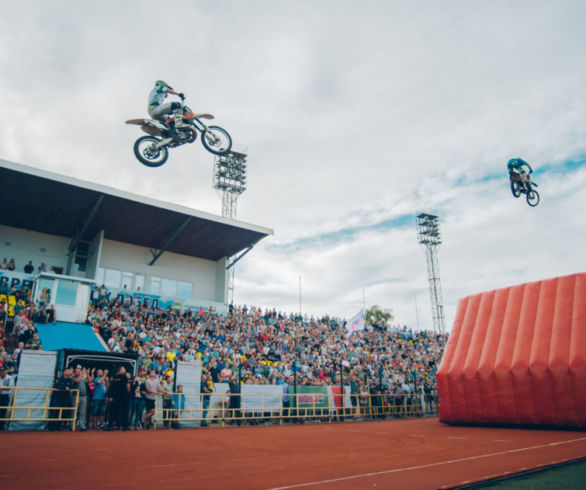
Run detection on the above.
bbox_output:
[417,213,446,333]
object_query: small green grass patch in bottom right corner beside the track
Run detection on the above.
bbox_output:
[484,460,586,490]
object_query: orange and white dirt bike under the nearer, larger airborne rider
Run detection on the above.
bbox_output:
[126,98,232,167]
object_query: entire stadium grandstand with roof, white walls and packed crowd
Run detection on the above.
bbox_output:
[0,157,445,429]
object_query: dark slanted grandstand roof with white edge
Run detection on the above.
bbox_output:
[0,159,273,260]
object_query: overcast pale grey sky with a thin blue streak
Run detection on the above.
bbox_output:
[0,0,586,328]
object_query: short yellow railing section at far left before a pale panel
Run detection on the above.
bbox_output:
[0,387,79,431]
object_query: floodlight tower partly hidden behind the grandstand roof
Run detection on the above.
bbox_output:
[214,151,247,303]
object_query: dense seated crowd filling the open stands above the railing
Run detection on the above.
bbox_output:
[88,286,447,414]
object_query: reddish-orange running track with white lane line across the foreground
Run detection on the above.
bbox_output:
[0,418,586,490]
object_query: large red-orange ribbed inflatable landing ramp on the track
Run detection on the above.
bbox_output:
[437,273,586,427]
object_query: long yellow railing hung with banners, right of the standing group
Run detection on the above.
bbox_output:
[153,392,438,428]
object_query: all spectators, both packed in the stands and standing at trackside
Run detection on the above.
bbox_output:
[0,286,447,430]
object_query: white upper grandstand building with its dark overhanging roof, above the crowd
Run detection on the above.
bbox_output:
[0,160,273,321]
